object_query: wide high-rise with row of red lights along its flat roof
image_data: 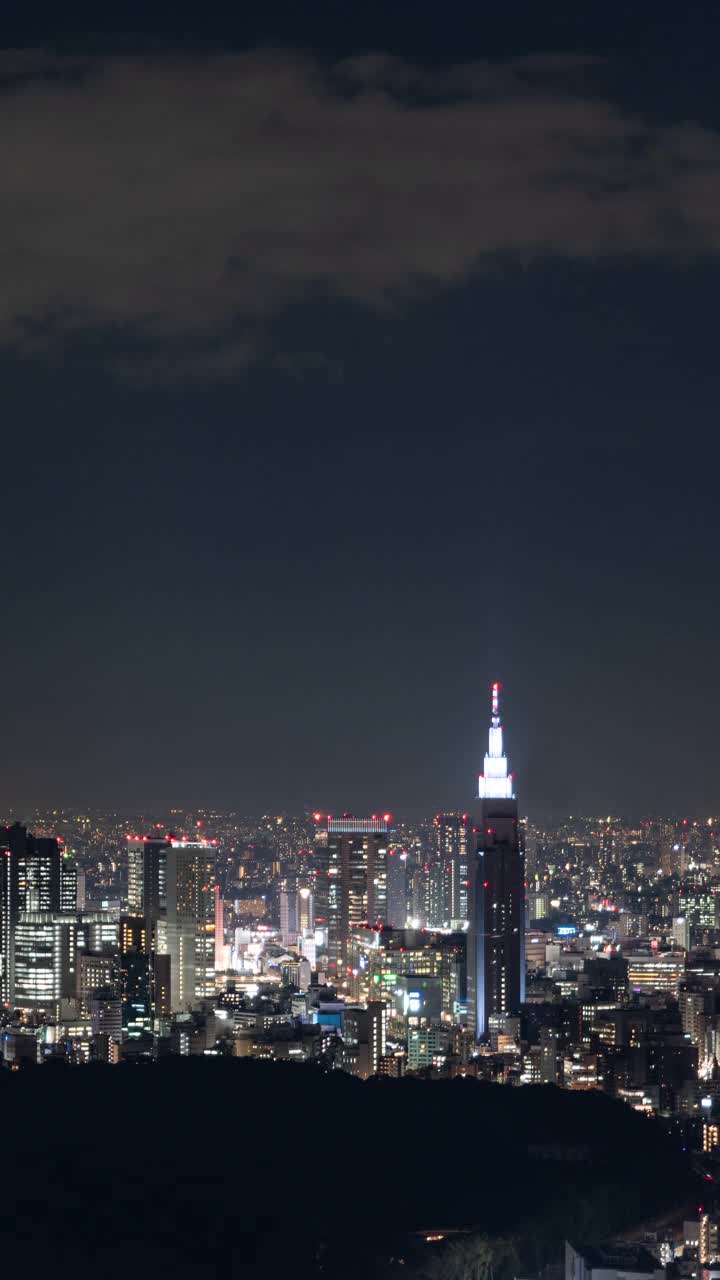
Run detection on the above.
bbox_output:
[315,813,391,969]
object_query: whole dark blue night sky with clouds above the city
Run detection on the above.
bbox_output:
[0,0,720,817]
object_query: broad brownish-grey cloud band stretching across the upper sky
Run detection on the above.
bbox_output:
[0,50,720,379]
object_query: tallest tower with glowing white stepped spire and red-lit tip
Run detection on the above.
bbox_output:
[468,682,525,1039]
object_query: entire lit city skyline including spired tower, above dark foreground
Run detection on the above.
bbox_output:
[0,685,720,1146]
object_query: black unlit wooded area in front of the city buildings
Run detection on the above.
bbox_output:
[0,1059,692,1280]
